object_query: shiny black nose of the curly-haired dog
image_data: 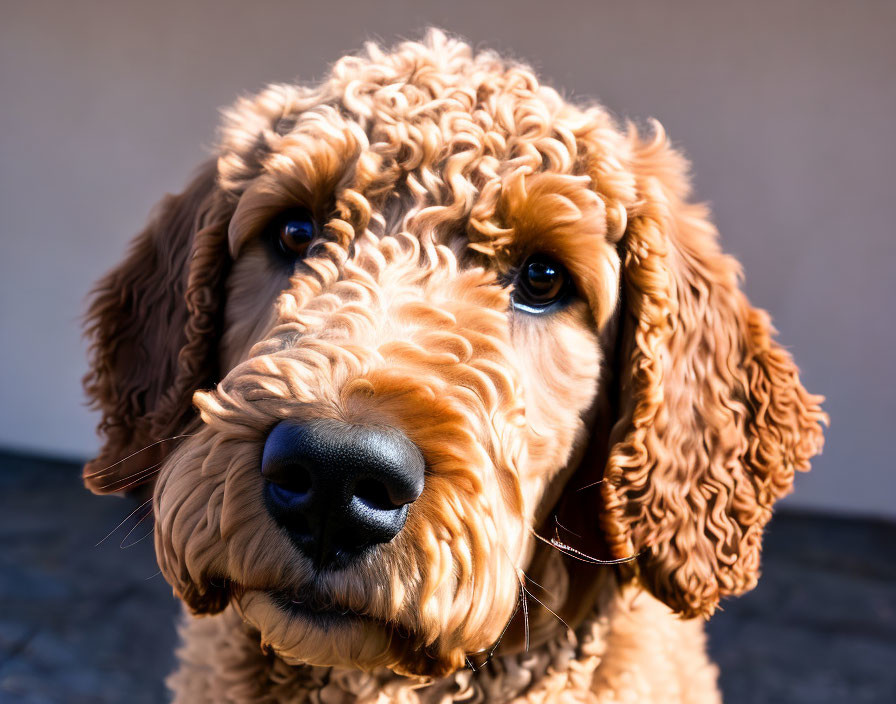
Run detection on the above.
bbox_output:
[261,419,424,567]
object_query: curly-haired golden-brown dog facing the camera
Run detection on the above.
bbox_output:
[85,32,825,702]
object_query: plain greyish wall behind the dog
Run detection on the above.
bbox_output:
[0,0,896,517]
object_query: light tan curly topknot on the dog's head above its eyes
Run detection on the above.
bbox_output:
[219,42,613,210]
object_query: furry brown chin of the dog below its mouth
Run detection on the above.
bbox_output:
[235,590,464,678]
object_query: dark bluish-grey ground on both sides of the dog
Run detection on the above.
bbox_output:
[0,453,896,704]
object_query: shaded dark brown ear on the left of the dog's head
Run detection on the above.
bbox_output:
[84,161,230,494]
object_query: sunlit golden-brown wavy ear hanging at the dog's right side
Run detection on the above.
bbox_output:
[600,125,827,616]
